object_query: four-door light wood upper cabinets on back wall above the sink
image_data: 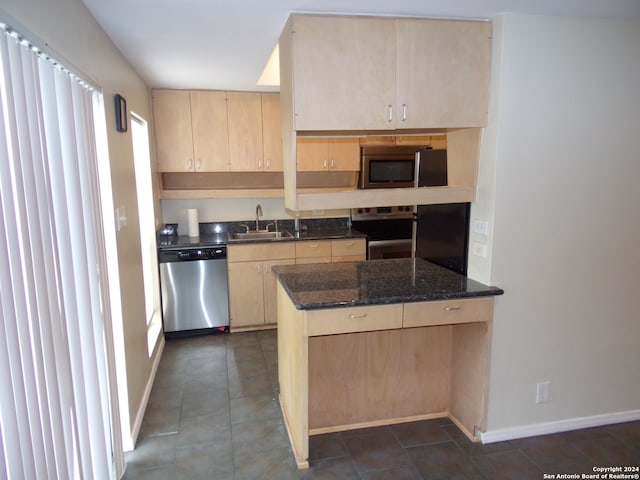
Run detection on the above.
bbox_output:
[152,90,282,172]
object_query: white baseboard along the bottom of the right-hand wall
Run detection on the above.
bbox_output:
[480,410,640,443]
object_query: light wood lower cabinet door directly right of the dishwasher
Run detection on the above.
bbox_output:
[227,262,264,330]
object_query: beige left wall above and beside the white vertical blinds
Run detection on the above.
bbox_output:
[0,0,158,448]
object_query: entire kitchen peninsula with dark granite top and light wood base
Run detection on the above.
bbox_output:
[273,258,504,468]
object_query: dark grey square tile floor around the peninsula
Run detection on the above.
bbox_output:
[124,331,640,480]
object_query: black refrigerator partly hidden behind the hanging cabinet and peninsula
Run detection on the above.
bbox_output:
[414,149,471,275]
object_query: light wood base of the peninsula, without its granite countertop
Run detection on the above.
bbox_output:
[278,284,493,468]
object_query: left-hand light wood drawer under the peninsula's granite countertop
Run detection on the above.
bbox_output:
[307,304,402,337]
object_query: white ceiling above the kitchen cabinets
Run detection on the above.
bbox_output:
[83,0,640,91]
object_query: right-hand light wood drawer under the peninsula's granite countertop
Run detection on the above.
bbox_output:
[402,297,493,328]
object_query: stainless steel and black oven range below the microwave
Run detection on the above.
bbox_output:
[351,206,414,260]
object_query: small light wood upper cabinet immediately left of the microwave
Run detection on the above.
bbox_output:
[296,137,360,172]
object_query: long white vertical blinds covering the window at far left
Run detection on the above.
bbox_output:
[0,25,113,479]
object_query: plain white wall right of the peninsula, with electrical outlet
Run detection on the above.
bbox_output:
[478,15,640,440]
